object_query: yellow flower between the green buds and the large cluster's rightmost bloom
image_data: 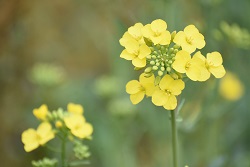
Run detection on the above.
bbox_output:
[172,50,209,81]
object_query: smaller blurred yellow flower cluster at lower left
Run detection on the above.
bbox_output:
[21,103,93,165]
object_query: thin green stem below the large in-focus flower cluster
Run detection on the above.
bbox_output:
[171,110,178,167]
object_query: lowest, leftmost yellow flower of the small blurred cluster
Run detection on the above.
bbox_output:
[22,122,55,152]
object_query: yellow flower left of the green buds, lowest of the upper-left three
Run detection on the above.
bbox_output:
[120,39,151,67]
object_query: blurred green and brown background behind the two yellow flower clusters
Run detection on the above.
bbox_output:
[0,0,250,167]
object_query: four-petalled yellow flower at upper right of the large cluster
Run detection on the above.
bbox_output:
[173,25,206,53]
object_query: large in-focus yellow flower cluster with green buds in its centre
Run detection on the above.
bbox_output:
[119,19,226,110]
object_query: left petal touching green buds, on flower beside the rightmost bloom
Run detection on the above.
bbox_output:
[172,50,191,73]
